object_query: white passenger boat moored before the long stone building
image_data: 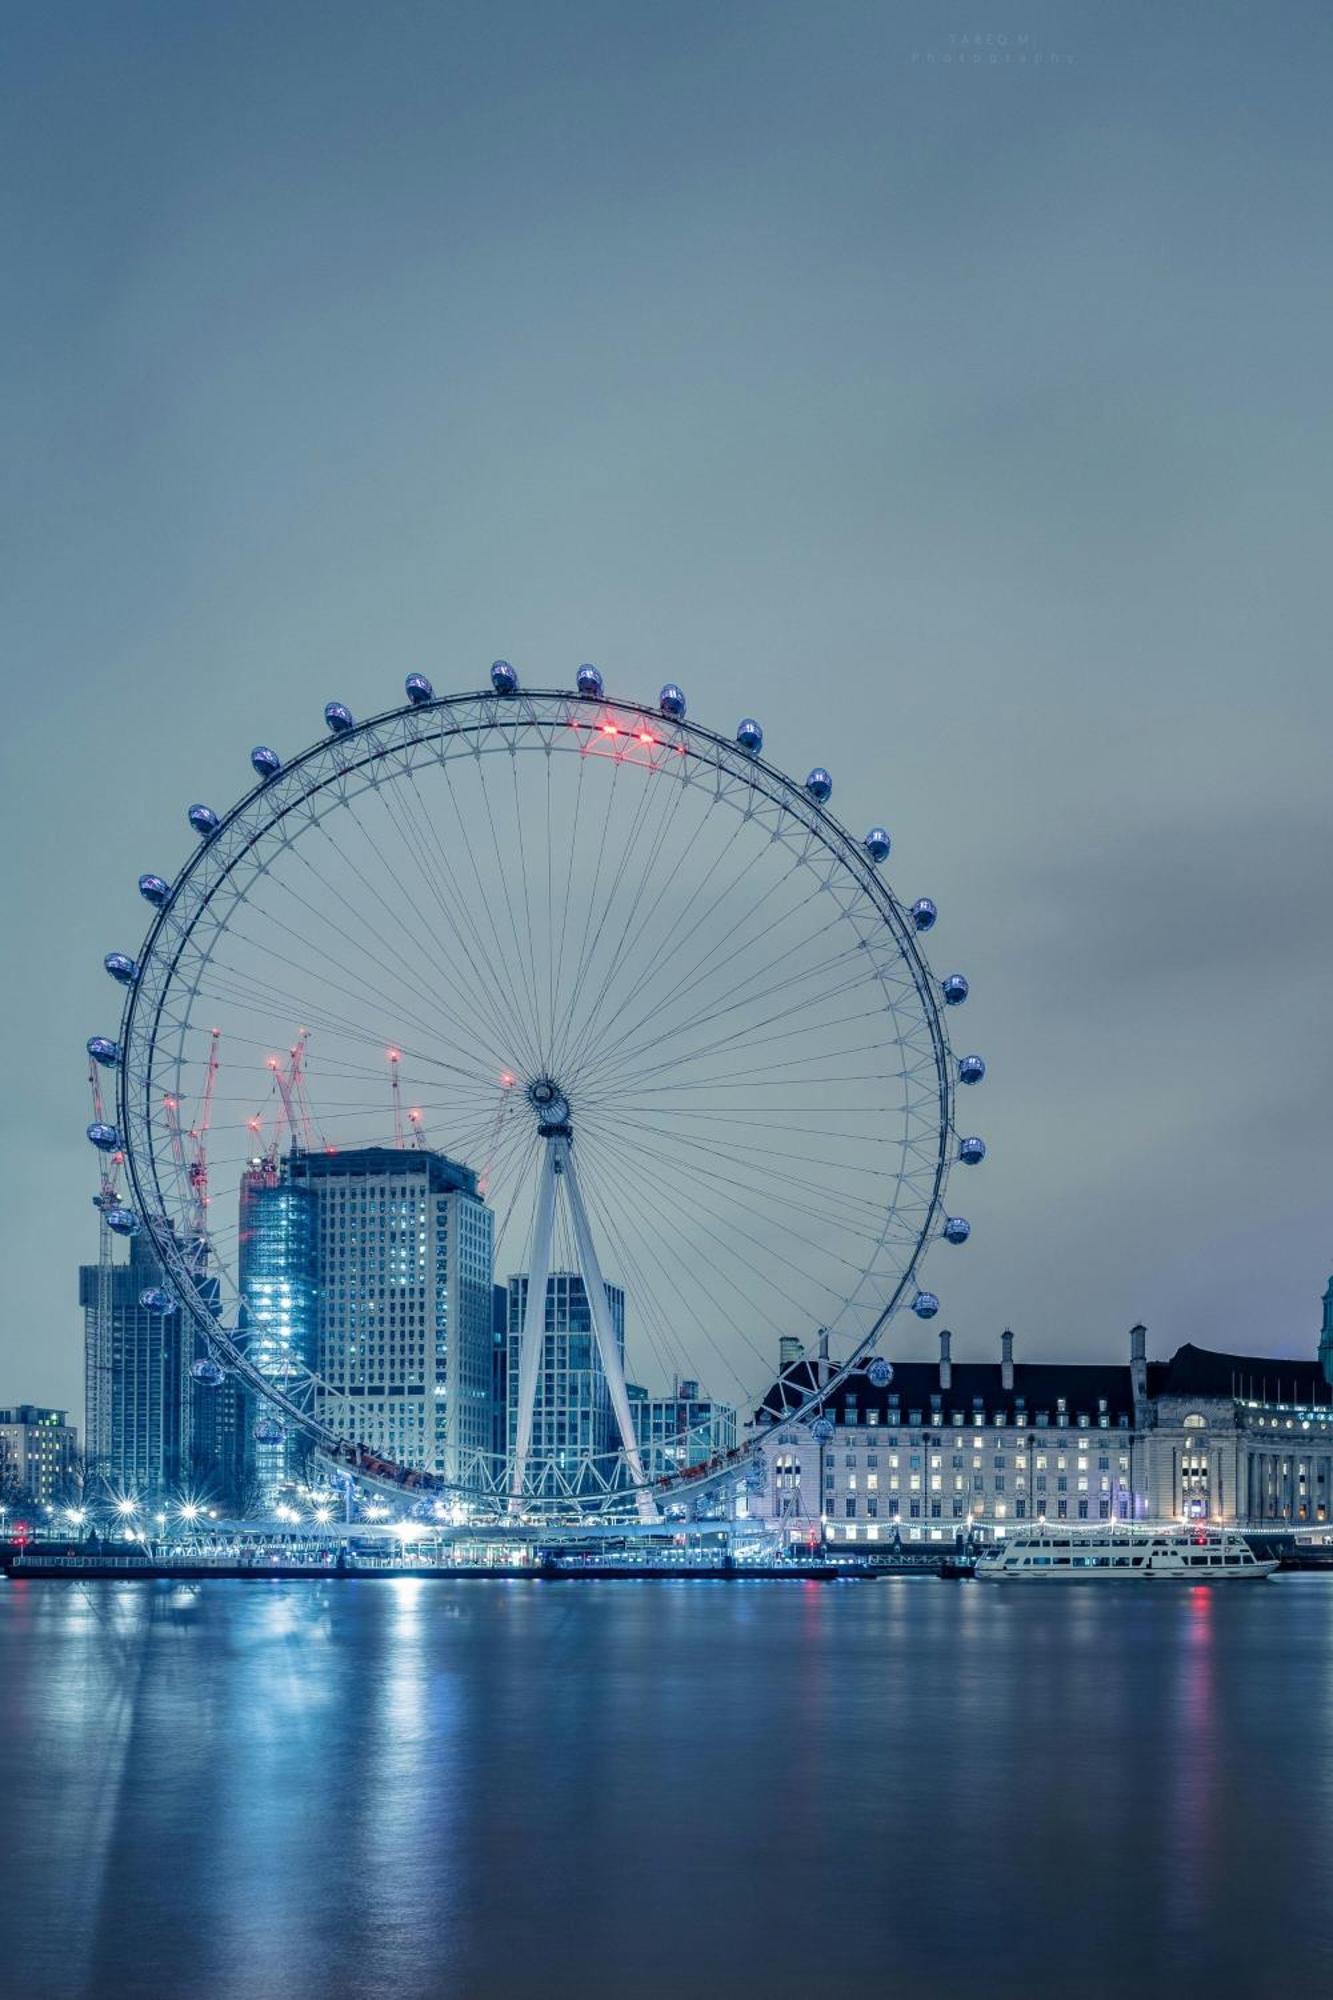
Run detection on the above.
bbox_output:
[977,1526,1277,1584]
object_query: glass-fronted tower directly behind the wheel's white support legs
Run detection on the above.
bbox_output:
[506,1270,624,1476]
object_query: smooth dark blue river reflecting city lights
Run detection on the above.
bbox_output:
[0,1576,1333,2000]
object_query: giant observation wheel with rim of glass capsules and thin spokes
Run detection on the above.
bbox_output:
[88,660,985,1518]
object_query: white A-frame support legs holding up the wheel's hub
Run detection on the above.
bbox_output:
[508,1130,656,1520]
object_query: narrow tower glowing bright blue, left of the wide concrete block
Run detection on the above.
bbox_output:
[236,1164,320,1512]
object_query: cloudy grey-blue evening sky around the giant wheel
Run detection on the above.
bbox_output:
[0,0,1333,1410]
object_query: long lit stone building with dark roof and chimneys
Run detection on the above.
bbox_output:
[745,1284,1333,1544]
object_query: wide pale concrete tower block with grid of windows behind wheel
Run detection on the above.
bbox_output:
[280,1146,494,1484]
